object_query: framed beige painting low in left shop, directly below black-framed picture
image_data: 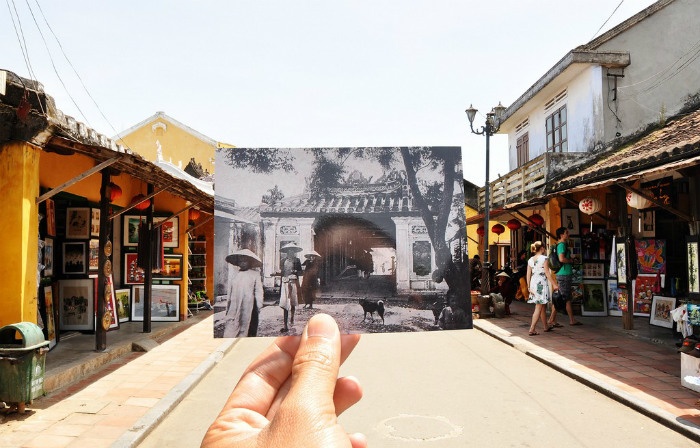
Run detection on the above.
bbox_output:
[58,278,95,331]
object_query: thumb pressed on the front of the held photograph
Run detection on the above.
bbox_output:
[287,314,340,424]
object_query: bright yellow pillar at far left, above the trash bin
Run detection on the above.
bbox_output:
[0,142,41,326]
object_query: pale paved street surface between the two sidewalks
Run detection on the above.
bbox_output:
[139,324,693,448]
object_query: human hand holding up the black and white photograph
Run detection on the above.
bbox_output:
[202,314,367,448]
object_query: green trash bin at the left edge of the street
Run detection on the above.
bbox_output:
[0,322,49,413]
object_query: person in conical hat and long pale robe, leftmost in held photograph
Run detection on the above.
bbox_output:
[224,249,263,338]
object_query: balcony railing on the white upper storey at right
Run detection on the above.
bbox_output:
[478,152,588,211]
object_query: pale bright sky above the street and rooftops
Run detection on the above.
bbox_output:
[0,0,654,185]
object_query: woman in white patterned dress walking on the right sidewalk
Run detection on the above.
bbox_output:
[527,241,558,336]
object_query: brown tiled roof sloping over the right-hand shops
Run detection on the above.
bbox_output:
[545,110,700,193]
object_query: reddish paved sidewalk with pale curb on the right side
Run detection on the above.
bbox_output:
[474,302,700,442]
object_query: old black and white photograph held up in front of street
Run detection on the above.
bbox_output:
[214,147,472,337]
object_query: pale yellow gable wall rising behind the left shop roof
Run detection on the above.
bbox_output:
[120,117,215,173]
